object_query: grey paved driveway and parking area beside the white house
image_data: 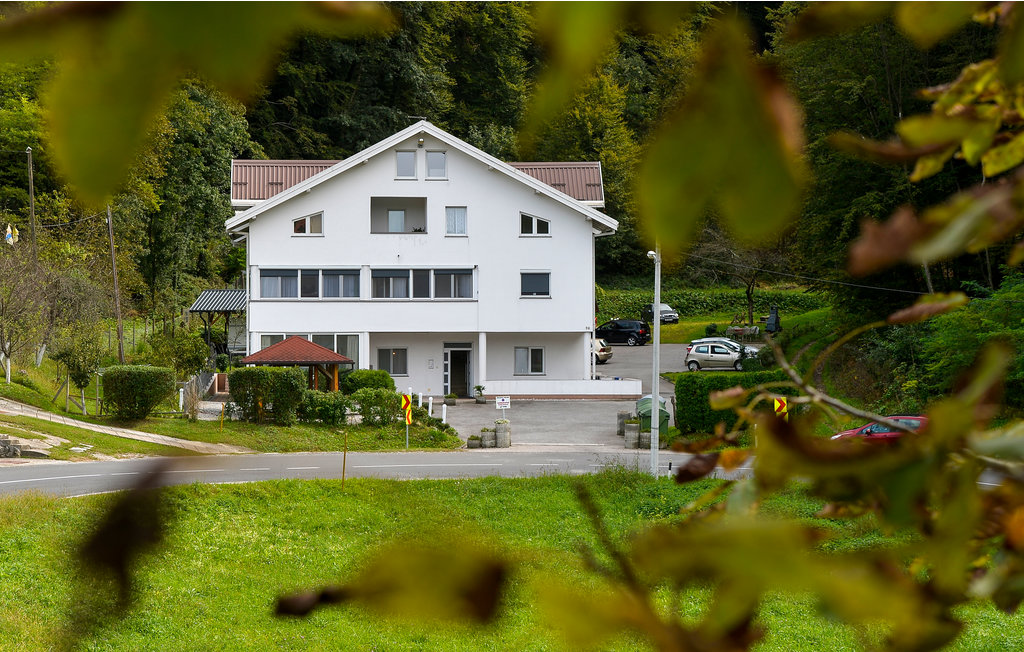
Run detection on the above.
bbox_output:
[444,344,686,450]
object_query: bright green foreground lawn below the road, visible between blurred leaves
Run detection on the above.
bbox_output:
[0,471,1024,652]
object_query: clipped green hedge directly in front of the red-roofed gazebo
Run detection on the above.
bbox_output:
[227,366,306,426]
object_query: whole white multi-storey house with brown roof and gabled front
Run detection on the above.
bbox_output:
[226,122,640,397]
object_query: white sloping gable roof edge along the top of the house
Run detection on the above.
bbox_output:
[224,121,618,232]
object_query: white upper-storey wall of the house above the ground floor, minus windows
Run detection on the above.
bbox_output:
[249,132,594,333]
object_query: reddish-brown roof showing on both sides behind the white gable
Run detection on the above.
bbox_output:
[231,161,604,205]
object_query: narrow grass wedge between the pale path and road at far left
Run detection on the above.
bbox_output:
[0,415,196,461]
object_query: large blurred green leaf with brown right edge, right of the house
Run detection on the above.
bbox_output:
[637,19,805,251]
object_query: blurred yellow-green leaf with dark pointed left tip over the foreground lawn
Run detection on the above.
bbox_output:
[278,538,511,623]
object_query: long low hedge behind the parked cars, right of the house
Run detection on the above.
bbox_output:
[597,289,828,325]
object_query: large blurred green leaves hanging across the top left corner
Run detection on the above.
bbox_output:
[0,2,390,202]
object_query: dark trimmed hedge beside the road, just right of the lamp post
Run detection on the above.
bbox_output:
[676,370,796,433]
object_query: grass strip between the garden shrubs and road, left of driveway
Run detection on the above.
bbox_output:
[89,418,462,452]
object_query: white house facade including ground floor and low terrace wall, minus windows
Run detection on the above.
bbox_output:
[246,126,618,396]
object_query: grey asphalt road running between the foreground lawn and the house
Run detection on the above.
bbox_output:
[0,448,720,496]
